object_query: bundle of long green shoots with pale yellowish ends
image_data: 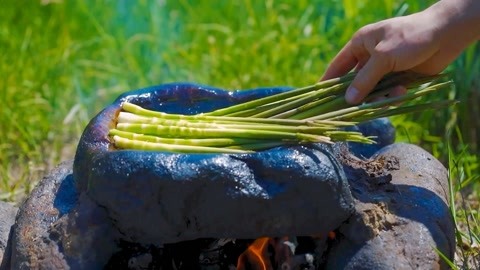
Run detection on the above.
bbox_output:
[109,72,454,154]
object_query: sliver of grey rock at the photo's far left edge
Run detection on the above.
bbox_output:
[0,201,18,269]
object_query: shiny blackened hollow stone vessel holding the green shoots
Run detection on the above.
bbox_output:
[74,84,353,244]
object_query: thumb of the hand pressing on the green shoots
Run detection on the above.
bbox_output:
[345,56,389,104]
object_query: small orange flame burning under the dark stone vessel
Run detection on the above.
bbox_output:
[237,237,273,270]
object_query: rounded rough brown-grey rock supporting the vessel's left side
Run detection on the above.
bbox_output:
[11,161,117,269]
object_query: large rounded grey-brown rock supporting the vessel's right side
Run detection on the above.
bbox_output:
[327,144,455,269]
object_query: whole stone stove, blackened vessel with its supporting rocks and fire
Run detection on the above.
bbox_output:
[0,84,455,269]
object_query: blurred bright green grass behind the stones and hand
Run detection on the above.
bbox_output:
[0,0,480,268]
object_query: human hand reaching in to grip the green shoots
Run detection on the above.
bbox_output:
[321,0,480,104]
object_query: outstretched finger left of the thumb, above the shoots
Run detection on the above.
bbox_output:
[320,42,358,81]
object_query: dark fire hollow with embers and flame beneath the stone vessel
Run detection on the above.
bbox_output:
[106,237,326,270]
